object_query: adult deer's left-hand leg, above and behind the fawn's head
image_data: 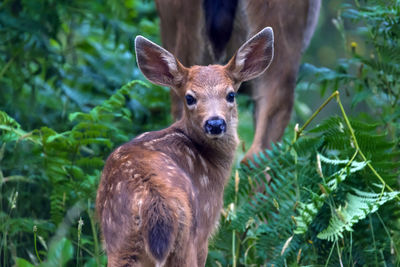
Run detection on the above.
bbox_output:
[156,0,204,120]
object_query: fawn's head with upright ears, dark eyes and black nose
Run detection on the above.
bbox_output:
[135,27,274,142]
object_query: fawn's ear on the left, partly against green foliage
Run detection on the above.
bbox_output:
[135,35,187,90]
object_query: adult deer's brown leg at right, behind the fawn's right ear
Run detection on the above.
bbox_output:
[244,0,319,160]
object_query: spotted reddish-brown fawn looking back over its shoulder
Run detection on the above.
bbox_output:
[96,28,273,267]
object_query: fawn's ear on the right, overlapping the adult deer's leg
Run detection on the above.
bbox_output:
[225,27,274,83]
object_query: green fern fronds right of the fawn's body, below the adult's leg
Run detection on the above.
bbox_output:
[209,114,400,266]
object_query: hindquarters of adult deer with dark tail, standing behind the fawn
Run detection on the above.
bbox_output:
[156,0,320,160]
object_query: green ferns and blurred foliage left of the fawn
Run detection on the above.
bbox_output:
[0,0,169,266]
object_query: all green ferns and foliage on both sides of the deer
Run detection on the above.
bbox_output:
[0,0,400,266]
